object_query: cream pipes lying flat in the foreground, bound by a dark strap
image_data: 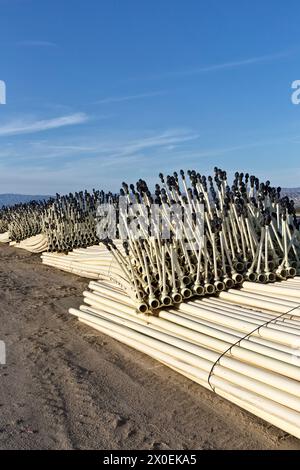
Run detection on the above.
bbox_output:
[70,278,300,438]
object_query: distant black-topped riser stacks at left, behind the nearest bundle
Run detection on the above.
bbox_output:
[0,190,114,253]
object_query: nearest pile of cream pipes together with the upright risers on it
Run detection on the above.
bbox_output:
[1,168,300,438]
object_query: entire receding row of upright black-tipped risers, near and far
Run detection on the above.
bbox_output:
[0,167,300,311]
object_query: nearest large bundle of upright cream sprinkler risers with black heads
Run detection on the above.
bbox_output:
[93,168,300,310]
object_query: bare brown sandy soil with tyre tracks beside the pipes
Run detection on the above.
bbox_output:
[0,246,300,449]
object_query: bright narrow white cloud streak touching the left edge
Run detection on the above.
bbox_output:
[0,113,88,137]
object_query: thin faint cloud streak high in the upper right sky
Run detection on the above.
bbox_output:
[138,51,291,80]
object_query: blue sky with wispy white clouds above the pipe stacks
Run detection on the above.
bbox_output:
[0,0,300,194]
